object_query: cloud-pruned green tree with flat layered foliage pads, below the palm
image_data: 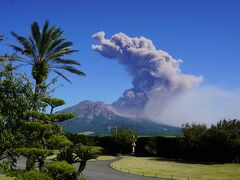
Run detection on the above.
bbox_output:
[17,97,75,171]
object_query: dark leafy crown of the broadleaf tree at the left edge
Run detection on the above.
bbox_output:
[0,64,33,133]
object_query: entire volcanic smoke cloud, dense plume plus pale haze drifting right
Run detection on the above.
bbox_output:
[92,32,240,126]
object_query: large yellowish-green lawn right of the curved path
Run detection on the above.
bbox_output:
[111,156,240,180]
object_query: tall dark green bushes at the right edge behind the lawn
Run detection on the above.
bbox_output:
[182,120,240,162]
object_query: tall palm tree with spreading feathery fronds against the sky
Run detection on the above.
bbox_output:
[10,21,85,110]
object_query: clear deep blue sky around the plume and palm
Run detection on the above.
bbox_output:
[0,0,240,110]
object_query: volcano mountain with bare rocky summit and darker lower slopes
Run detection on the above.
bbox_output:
[60,101,181,135]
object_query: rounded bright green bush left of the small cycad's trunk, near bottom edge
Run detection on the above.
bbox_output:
[45,161,77,180]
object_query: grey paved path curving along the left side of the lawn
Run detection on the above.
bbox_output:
[83,158,156,180]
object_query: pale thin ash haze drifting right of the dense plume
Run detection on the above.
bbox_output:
[152,85,240,126]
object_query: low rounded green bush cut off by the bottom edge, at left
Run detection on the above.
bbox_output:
[16,170,52,180]
